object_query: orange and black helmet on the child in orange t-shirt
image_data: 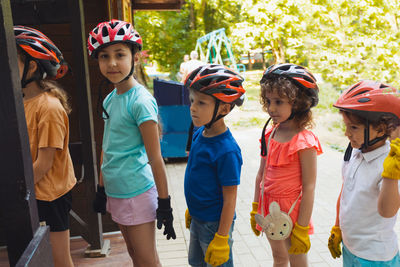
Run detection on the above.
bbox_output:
[14,26,68,84]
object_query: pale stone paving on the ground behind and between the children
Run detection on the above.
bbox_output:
[157,128,400,267]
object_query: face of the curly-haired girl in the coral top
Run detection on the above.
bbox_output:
[265,91,292,123]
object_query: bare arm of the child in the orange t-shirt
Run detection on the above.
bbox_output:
[33,147,56,184]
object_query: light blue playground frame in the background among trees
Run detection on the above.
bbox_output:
[195,28,245,71]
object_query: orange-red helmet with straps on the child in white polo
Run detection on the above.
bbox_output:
[333,80,400,161]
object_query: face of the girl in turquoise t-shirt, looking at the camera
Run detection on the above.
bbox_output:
[98,43,133,84]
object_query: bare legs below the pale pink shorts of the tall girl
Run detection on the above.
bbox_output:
[119,222,161,267]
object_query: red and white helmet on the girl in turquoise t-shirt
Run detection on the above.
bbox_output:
[88,19,143,58]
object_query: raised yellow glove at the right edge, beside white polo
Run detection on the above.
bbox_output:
[382,138,400,180]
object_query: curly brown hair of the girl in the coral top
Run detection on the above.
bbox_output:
[260,74,314,129]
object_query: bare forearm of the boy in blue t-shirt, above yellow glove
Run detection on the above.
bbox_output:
[218,185,237,236]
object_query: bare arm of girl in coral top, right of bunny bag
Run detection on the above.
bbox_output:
[297,148,317,226]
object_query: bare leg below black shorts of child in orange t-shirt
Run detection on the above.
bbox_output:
[50,230,74,267]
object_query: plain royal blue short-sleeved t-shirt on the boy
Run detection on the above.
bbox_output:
[185,127,243,222]
